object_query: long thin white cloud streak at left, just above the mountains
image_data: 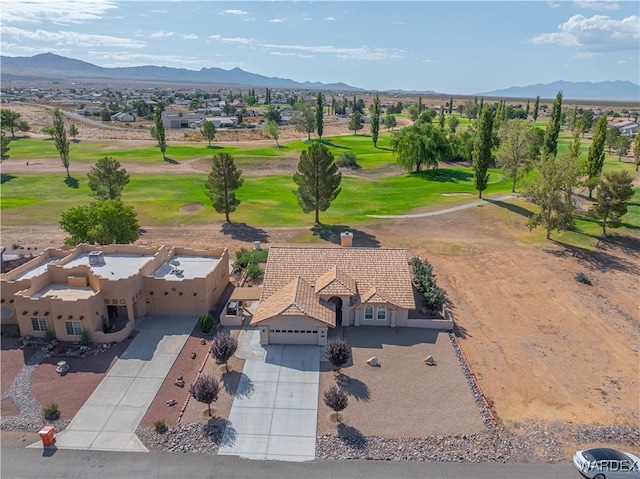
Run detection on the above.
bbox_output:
[0,26,146,48]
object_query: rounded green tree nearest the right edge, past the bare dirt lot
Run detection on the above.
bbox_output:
[589,170,633,235]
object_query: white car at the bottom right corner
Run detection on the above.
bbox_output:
[573,447,640,479]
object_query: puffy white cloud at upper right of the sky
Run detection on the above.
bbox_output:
[529,15,640,52]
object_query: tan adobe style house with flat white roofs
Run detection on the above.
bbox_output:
[0,245,229,342]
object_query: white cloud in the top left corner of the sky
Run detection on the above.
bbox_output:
[2,0,117,24]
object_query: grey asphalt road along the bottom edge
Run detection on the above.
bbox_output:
[0,446,581,479]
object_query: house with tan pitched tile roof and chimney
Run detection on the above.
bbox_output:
[251,233,420,345]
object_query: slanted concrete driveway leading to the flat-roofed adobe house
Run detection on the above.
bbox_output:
[42,316,197,452]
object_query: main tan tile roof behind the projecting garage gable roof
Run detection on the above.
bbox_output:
[256,246,416,313]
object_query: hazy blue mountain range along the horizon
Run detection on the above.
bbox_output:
[0,53,640,102]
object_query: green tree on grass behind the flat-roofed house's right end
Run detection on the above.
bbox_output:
[205,153,244,223]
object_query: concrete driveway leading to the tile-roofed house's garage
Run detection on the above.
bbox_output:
[218,330,321,461]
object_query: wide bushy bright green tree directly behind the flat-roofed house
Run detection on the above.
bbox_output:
[60,198,140,246]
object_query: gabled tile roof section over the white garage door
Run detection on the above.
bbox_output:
[251,276,336,327]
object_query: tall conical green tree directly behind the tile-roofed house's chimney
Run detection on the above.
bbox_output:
[293,143,342,224]
